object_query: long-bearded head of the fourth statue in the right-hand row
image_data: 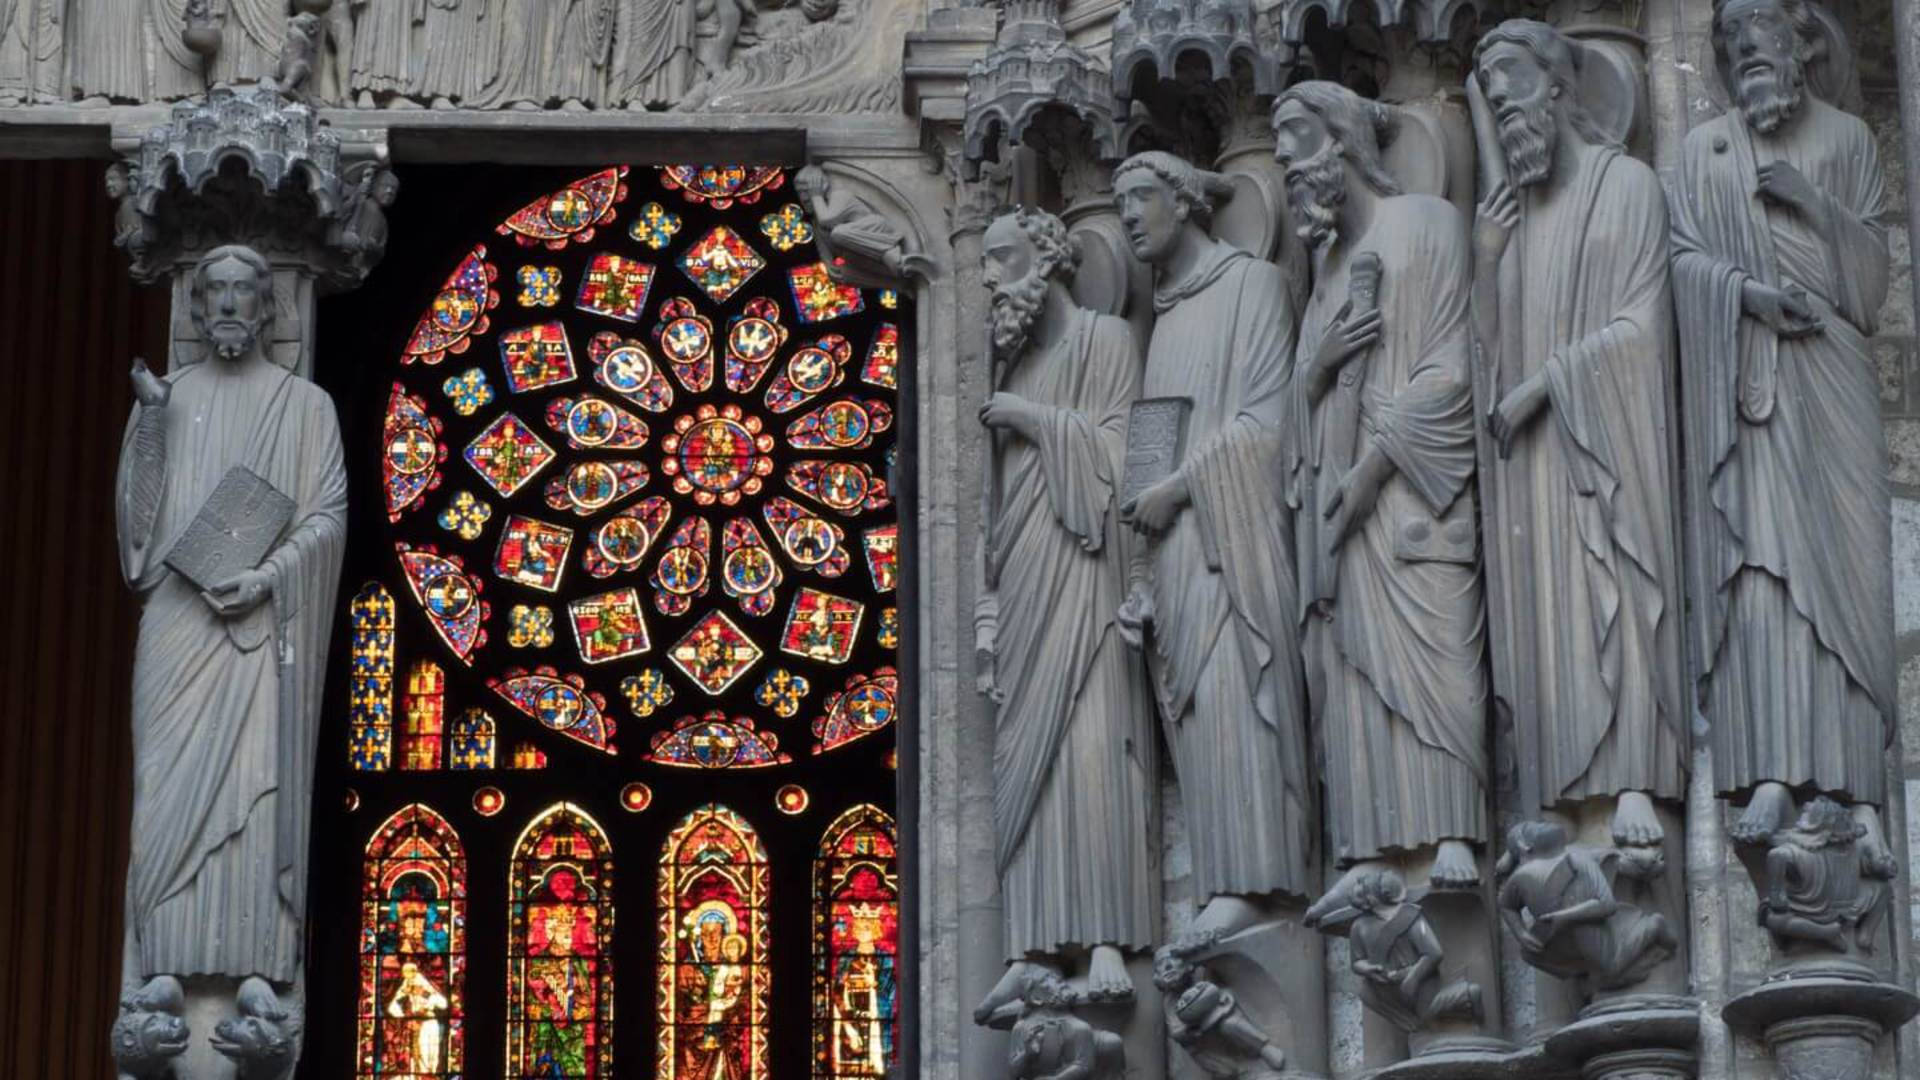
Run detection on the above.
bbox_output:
[1473,19,1613,186]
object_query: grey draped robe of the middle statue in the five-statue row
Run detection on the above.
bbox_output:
[1296,194,1488,863]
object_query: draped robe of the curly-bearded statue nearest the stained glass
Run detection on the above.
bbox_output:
[987,309,1160,959]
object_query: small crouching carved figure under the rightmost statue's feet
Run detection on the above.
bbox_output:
[1761,796,1899,953]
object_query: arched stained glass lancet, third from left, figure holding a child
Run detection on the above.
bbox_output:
[655,803,772,1080]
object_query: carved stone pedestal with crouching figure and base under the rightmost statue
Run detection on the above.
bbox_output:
[1722,796,1920,1080]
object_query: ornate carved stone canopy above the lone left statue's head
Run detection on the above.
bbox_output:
[108,79,399,373]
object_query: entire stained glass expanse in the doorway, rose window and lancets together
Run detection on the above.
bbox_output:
[307,165,916,1080]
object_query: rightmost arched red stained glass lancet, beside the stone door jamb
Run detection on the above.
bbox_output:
[814,803,900,1080]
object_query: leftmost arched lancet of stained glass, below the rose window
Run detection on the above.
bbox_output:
[355,803,467,1080]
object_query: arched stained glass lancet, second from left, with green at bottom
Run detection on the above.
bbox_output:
[507,803,612,1080]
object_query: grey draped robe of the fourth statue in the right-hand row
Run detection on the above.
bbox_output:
[1476,135,1686,807]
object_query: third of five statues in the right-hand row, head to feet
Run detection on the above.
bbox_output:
[1273,81,1488,888]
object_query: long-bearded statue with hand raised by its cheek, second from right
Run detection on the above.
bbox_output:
[1469,19,1688,844]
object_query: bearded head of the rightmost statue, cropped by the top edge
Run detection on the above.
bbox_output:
[1713,0,1818,135]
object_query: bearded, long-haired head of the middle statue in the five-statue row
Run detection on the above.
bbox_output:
[1273,79,1400,244]
